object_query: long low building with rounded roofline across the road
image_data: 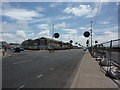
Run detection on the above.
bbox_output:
[21,37,72,50]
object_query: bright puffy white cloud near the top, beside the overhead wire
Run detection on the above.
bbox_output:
[64,2,102,18]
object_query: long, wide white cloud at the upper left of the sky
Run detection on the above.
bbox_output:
[3,9,43,20]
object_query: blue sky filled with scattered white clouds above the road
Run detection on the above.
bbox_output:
[1,2,118,45]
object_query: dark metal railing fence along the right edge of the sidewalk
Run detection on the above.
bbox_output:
[89,39,120,86]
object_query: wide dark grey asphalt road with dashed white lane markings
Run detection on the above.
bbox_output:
[2,50,84,90]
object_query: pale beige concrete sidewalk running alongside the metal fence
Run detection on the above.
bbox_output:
[71,51,118,88]
